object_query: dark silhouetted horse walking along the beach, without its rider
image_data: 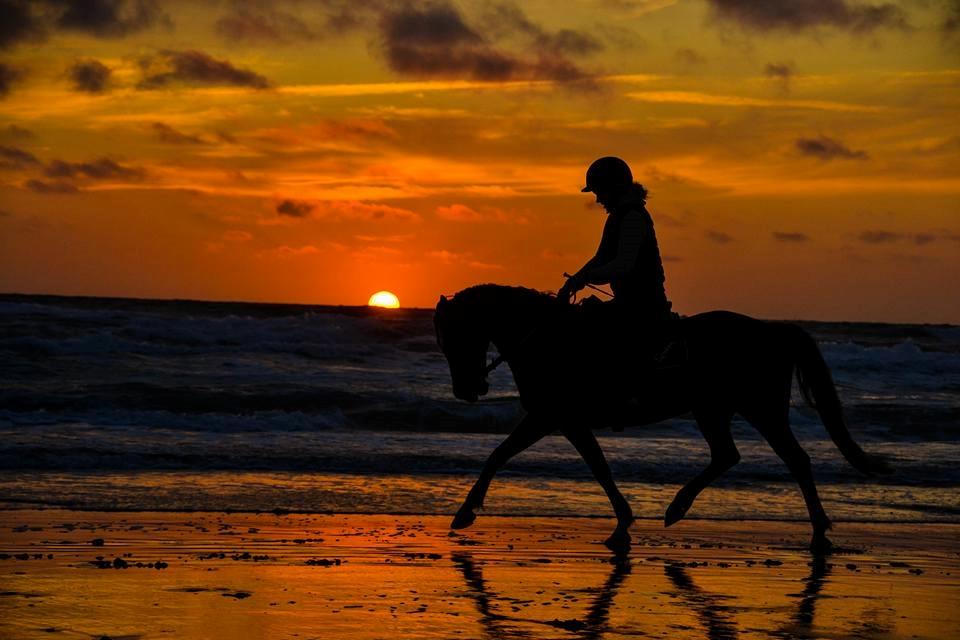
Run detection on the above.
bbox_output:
[433,284,891,553]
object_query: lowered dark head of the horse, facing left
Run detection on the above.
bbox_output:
[433,296,490,402]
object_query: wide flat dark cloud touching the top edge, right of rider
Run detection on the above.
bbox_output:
[707,0,908,33]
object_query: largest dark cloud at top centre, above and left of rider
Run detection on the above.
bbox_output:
[380,3,588,82]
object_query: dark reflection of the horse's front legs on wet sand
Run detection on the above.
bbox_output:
[452,552,630,640]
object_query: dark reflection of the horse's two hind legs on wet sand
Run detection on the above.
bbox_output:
[664,555,831,640]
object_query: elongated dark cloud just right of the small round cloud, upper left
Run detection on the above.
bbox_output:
[137,50,270,89]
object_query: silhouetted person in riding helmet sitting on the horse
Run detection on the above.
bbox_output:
[557,156,673,337]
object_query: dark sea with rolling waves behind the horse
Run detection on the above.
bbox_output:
[0,294,960,522]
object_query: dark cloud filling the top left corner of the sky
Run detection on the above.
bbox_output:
[0,0,172,50]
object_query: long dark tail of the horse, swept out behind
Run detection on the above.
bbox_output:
[791,325,893,474]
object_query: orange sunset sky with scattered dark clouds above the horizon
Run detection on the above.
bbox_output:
[0,0,960,323]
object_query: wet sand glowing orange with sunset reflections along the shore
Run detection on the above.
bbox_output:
[0,510,960,640]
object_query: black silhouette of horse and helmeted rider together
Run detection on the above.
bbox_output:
[434,157,889,552]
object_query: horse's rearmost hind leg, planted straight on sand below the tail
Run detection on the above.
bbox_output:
[744,416,833,553]
